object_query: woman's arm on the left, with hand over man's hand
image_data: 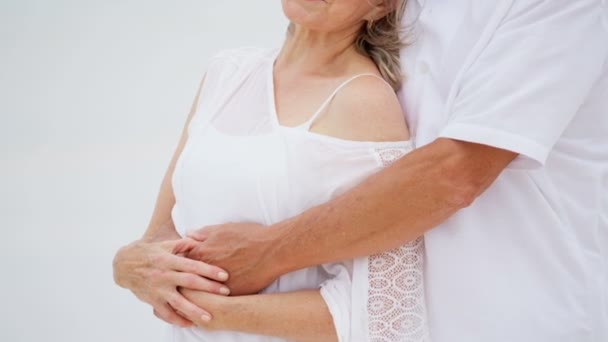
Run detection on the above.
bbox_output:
[113,76,229,326]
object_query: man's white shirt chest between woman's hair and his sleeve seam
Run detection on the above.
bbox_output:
[399,0,513,146]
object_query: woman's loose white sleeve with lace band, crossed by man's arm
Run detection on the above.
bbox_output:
[320,147,429,342]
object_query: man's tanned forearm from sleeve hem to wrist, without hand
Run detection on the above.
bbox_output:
[263,139,516,274]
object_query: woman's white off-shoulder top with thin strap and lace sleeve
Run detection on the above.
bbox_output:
[170,49,427,342]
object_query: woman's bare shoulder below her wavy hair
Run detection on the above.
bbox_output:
[312,76,409,141]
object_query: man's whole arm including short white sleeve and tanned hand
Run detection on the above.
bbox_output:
[188,0,608,300]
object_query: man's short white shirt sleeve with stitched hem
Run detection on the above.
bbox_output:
[440,0,608,168]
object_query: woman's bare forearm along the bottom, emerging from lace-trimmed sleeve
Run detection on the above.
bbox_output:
[180,289,338,342]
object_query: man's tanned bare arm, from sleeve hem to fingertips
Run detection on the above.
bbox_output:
[190,139,517,294]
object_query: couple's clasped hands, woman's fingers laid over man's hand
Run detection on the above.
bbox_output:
[113,223,276,327]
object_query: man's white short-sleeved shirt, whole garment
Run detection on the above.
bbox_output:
[399,0,608,342]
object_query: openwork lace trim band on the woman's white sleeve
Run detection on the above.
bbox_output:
[367,148,429,342]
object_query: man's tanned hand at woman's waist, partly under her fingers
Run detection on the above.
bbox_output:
[186,223,282,295]
